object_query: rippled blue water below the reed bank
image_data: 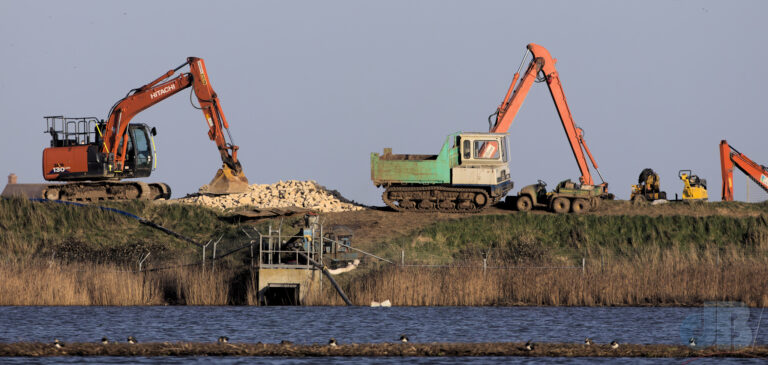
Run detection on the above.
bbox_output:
[0,307,768,364]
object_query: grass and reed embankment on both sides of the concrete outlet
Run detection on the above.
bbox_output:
[0,200,768,306]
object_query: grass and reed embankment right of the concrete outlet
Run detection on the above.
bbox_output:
[310,209,768,307]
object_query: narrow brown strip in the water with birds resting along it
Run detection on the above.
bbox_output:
[0,342,768,358]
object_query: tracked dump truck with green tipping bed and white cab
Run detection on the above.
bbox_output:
[371,132,513,213]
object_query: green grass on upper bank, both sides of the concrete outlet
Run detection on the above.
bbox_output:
[0,199,768,264]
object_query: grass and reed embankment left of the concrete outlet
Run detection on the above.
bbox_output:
[0,199,268,305]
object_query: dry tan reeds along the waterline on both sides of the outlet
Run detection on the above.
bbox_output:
[0,243,768,307]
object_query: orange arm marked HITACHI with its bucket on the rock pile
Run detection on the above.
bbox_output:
[101,57,248,194]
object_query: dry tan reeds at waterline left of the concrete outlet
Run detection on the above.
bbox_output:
[0,262,232,305]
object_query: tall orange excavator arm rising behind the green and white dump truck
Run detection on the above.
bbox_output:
[484,43,612,198]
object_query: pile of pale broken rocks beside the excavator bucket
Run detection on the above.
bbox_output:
[178,180,365,213]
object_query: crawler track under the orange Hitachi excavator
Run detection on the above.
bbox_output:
[38,181,171,202]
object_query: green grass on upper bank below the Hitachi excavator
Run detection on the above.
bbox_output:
[0,199,244,263]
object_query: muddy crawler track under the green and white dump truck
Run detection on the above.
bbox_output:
[381,185,499,213]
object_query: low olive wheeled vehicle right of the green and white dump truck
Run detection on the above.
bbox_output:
[505,179,603,214]
